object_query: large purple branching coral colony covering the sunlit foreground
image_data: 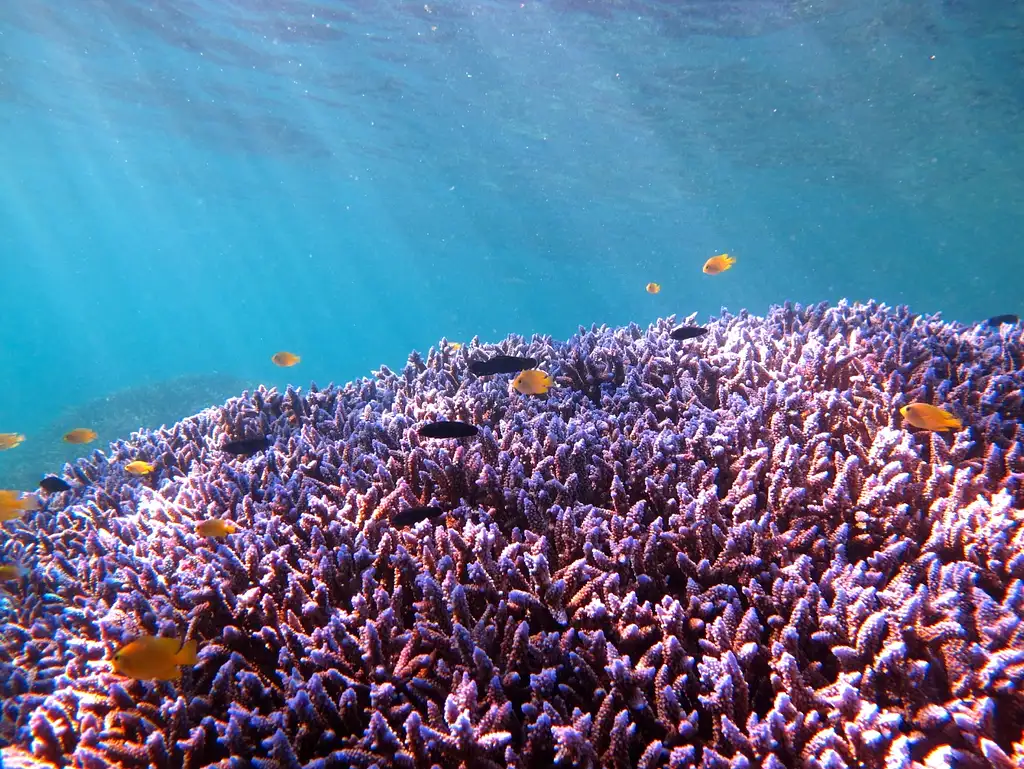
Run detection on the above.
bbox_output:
[0,303,1024,769]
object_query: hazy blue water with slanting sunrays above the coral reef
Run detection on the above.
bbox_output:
[0,0,1024,481]
